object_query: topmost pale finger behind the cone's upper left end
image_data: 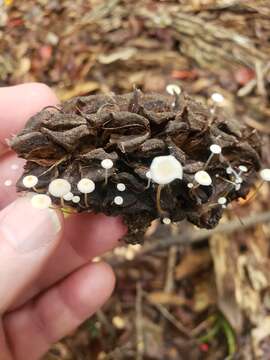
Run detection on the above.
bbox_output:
[0,83,58,154]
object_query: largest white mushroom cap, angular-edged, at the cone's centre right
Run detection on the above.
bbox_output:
[150,155,183,185]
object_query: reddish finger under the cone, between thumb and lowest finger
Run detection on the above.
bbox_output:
[13,214,127,308]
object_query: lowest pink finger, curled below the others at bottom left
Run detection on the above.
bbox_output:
[4,263,115,360]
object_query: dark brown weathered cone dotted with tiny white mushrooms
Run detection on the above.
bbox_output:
[11,90,260,243]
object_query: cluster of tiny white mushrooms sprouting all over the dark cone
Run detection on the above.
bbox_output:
[7,84,270,225]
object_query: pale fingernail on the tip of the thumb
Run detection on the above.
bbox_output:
[0,197,61,253]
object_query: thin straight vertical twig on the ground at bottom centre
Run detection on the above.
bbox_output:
[136,282,144,360]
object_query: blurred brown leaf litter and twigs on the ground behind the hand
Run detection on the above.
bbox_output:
[0,0,270,360]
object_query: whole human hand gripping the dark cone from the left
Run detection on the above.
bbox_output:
[0,83,126,360]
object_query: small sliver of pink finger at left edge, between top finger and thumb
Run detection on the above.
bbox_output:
[0,152,25,209]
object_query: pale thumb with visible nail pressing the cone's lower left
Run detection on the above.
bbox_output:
[0,197,62,314]
